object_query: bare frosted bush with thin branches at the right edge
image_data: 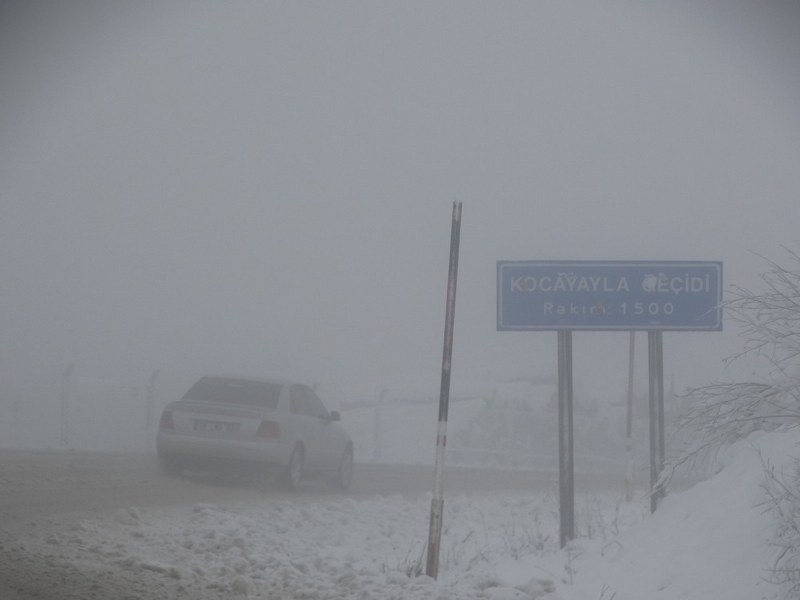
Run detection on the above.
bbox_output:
[673,249,800,598]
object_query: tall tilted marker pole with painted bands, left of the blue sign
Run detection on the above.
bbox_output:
[425,202,461,579]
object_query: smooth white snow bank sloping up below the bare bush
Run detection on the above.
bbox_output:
[500,428,800,600]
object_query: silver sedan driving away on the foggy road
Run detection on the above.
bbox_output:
[156,376,353,489]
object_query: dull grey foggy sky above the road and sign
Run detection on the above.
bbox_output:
[0,0,800,404]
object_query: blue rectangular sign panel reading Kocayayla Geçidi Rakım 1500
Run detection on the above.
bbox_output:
[497,261,722,331]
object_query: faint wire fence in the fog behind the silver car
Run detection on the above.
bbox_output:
[0,365,646,480]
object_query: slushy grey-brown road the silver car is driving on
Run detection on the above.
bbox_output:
[0,450,622,600]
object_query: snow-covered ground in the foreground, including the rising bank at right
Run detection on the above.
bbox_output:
[2,428,800,600]
